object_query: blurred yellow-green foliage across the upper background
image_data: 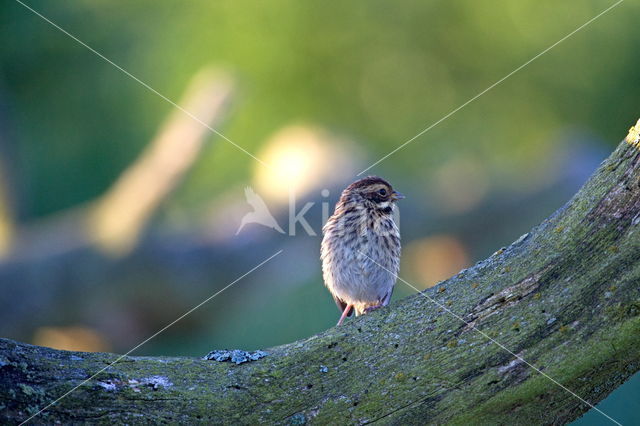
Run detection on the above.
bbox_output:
[0,0,640,218]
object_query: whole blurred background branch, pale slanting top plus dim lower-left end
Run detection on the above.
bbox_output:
[7,68,232,258]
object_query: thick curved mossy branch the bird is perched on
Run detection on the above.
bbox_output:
[0,138,640,424]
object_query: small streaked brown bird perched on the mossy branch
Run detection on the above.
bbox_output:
[320,176,405,325]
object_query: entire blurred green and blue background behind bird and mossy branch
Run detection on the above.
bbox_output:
[0,0,640,424]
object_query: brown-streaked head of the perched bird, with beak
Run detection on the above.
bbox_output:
[342,176,404,213]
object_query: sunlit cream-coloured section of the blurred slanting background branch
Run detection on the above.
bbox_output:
[87,69,232,255]
